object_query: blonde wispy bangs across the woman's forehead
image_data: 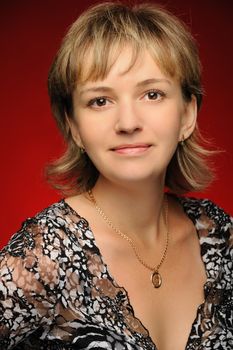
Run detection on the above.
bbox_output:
[72,38,180,85]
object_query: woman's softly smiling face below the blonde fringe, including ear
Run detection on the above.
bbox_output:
[70,48,196,189]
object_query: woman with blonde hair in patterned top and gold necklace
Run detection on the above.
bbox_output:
[0,3,233,350]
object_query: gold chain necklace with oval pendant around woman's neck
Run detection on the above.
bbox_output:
[88,190,169,288]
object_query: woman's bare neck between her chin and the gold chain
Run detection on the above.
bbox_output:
[89,177,164,244]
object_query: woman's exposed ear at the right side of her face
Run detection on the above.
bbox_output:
[179,95,197,141]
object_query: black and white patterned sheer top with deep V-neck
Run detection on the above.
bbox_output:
[0,198,233,350]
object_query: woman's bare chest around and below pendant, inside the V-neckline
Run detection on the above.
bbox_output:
[96,235,206,350]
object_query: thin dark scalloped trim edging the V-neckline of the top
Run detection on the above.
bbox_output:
[60,194,220,350]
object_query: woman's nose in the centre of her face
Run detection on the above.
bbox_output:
[115,102,142,134]
